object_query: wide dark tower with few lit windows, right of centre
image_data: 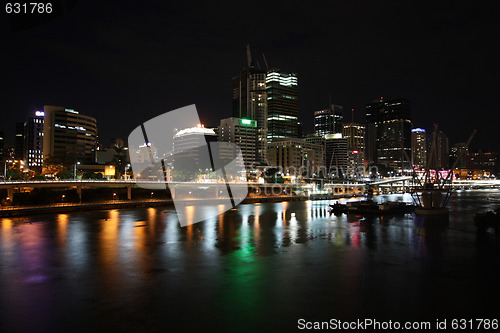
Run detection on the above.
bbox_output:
[366,98,411,172]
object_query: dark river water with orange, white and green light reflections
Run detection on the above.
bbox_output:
[0,191,500,332]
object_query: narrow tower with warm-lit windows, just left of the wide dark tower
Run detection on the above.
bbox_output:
[342,123,366,176]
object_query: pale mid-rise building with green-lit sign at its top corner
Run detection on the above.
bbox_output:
[218,117,257,169]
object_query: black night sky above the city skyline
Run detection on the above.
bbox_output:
[0,0,500,150]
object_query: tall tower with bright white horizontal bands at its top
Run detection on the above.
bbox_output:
[266,69,299,142]
